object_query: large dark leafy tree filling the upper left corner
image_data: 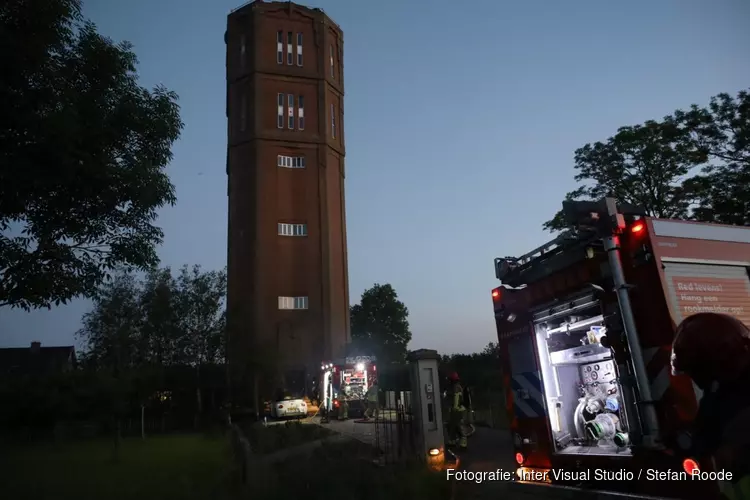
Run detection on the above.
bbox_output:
[0,0,183,310]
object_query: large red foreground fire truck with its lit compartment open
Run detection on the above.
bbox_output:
[492,199,750,499]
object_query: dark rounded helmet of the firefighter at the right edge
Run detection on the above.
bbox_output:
[671,313,750,390]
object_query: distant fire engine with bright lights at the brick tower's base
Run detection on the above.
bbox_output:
[321,356,377,418]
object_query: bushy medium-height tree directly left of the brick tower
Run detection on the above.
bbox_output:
[79,266,226,429]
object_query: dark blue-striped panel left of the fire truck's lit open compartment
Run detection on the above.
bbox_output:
[508,334,546,418]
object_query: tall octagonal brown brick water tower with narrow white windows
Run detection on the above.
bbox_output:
[225,0,350,404]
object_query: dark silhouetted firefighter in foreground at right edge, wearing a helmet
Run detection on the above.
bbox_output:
[671,313,750,500]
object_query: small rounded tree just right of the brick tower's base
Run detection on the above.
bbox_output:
[350,283,411,363]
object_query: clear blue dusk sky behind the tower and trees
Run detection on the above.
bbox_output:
[0,0,750,353]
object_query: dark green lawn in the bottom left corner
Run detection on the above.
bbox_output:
[0,435,231,500]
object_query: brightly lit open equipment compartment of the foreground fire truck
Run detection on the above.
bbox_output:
[533,295,631,455]
